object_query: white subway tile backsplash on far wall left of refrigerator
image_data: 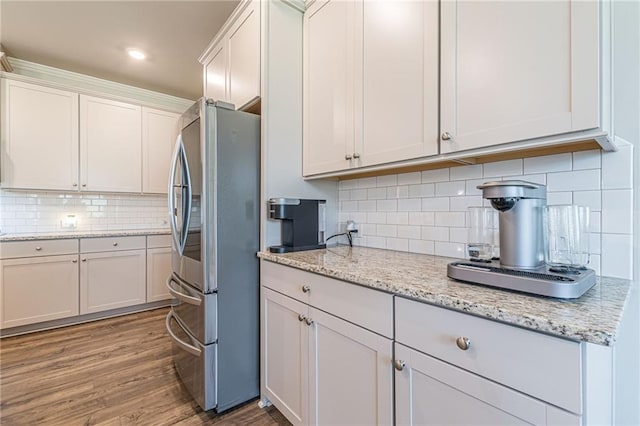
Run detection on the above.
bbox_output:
[0,190,169,234]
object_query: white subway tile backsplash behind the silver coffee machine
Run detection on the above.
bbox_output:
[339,146,633,279]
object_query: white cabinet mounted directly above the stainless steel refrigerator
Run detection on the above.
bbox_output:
[200,0,260,109]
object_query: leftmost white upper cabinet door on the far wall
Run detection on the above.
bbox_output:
[0,79,78,191]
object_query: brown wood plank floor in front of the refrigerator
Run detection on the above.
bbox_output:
[0,308,289,426]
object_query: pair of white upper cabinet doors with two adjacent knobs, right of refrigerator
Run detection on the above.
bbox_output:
[303,0,438,176]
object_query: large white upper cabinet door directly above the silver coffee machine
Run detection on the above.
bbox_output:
[440,0,599,153]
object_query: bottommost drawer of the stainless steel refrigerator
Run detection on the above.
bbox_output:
[166,311,218,411]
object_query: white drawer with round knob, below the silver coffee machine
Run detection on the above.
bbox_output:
[396,297,582,414]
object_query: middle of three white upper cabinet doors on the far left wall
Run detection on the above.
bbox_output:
[80,95,142,192]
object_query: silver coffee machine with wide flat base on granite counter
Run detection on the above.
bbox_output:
[447,180,596,299]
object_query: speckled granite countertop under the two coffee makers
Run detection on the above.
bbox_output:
[258,246,637,346]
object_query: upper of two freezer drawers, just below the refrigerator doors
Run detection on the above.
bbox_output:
[167,274,218,345]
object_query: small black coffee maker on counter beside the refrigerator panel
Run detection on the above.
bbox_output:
[268,198,327,253]
